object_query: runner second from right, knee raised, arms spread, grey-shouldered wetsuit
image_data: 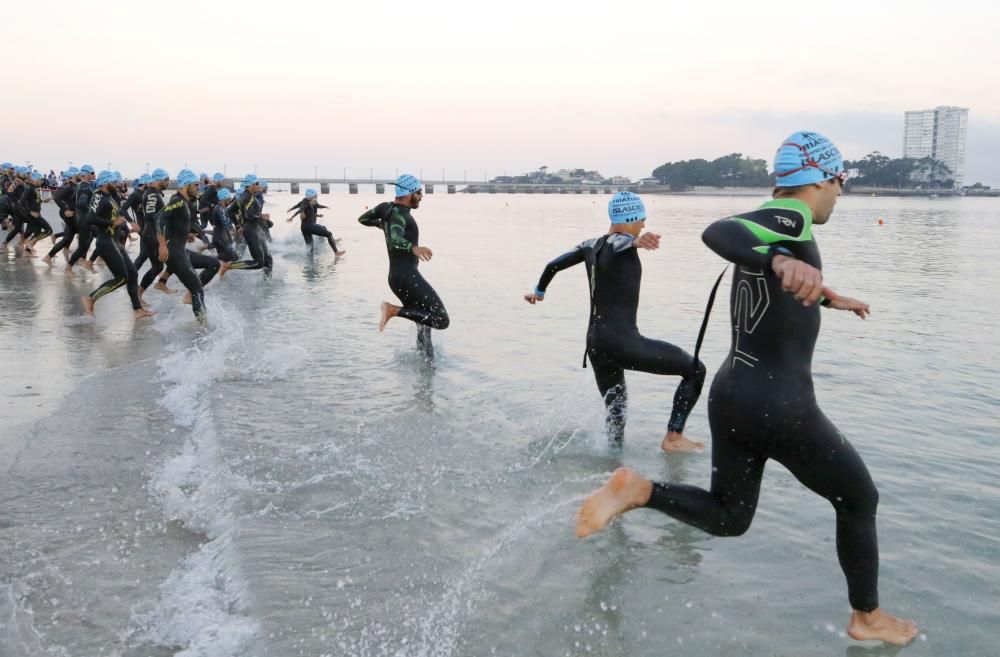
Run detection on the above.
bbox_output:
[524,192,705,452]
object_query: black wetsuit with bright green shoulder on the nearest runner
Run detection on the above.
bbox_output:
[647,200,878,612]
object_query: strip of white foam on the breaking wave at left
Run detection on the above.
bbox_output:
[134,304,259,657]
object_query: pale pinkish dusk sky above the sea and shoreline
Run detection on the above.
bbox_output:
[7,0,1000,186]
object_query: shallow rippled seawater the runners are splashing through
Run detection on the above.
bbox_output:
[0,193,1000,657]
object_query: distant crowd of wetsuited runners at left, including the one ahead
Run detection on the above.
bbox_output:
[0,162,344,322]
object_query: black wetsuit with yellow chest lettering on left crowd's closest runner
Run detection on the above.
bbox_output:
[156,193,219,321]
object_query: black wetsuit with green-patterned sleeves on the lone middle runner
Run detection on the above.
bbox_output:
[358,202,451,357]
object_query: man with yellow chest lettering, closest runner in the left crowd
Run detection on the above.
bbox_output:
[156,169,219,324]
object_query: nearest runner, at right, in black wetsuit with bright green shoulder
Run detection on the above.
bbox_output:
[577,132,917,644]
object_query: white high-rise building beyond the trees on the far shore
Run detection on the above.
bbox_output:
[903,106,969,187]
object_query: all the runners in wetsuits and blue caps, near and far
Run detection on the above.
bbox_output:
[0,132,917,645]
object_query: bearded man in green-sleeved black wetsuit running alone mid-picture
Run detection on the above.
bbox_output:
[358,174,451,360]
